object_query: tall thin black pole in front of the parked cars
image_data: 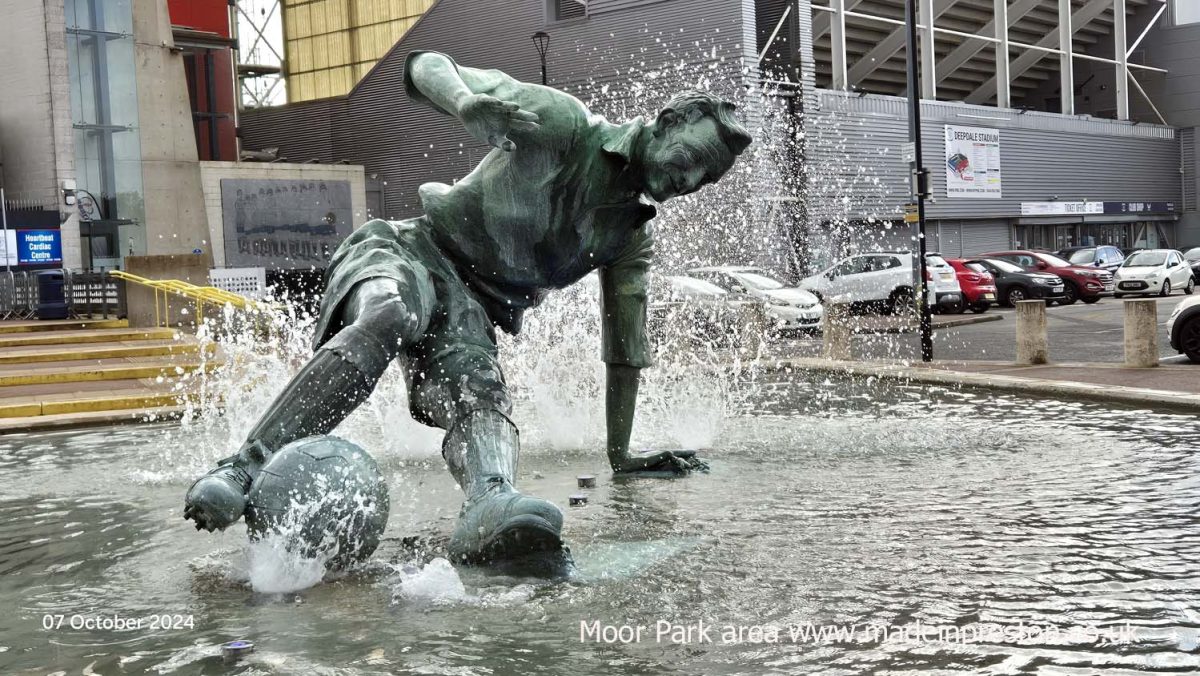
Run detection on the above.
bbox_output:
[905,0,934,361]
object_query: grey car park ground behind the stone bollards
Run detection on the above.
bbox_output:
[770,294,1187,364]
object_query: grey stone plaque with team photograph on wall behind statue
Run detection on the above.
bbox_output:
[221,179,354,270]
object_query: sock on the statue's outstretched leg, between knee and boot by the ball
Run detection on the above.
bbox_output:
[239,324,398,463]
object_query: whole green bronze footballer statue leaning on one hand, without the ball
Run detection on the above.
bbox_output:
[185,52,751,562]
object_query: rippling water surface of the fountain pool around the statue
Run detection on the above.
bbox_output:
[0,375,1200,675]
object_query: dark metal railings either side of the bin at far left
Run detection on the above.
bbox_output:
[0,270,126,319]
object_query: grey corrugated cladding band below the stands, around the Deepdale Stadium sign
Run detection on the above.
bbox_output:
[809,91,1182,220]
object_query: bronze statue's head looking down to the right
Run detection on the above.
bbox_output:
[644,115,736,202]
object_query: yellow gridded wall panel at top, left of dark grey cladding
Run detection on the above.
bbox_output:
[283,0,434,102]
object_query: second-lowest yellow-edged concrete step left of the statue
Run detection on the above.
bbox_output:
[0,357,217,391]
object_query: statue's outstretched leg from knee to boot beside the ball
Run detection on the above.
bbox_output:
[185,275,433,531]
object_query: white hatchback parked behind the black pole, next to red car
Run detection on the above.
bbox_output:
[800,251,945,312]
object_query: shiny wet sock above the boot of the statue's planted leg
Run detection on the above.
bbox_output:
[442,409,521,496]
